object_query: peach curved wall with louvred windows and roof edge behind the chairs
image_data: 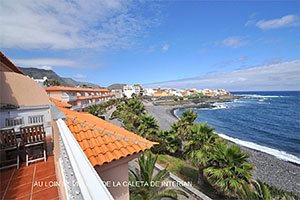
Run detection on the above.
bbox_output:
[0,53,52,135]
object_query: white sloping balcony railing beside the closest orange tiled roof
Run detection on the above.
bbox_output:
[56,119,113,200]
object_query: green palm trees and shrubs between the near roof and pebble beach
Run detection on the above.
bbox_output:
[115,98,298,200]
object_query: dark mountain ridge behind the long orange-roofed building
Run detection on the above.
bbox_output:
[19,67,100,88]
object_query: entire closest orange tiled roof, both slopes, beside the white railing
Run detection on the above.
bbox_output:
[59,108,155,166]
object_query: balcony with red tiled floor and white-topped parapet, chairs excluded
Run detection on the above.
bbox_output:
[0,105,113,200]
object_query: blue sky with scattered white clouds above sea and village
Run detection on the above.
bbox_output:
[0,0,300,91]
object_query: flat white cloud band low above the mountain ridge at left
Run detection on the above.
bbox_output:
[13,58,77,69]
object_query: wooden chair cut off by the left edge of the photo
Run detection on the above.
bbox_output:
[0,128,20,169]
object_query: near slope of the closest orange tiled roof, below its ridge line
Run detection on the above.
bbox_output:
[66,119,152,167]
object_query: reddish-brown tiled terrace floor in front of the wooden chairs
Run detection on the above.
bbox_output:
[0,156,59,200]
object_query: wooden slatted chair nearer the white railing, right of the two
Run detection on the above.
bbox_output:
[20,125,47,166]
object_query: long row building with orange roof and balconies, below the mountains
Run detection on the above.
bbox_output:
[45,86,115,111]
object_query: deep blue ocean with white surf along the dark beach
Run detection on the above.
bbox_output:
[175,91,300,164]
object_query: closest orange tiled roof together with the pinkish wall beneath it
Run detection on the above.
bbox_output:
[59,108,155,200]
